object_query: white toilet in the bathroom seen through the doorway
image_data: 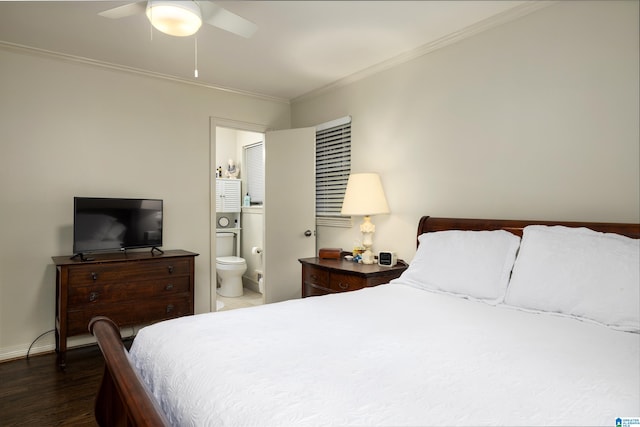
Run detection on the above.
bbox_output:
[216,233,247,297]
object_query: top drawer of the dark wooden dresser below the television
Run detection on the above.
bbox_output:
[69,259,190,286]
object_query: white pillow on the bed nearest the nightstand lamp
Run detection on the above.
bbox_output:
[392,230,520,303]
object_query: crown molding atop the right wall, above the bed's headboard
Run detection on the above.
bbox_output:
[290,0,558,104]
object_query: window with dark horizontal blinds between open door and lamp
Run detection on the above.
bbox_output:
[316,117,351,227]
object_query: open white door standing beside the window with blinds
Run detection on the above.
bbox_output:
[263,128,316,303]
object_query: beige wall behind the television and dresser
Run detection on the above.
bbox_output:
[0,49,290,359]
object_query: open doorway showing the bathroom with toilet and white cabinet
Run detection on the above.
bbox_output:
[210,118,265,311]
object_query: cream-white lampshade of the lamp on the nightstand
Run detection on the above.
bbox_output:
[341,173,389,216]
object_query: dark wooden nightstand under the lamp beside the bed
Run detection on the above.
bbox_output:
[298,258,407,298]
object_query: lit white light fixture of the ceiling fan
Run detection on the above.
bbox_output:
[147,0,202,37]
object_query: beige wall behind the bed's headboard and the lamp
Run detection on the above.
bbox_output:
[292,1,640,259]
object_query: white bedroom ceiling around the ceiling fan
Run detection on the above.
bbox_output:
[0,0,542,100]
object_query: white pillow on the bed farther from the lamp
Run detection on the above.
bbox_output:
[505,225,640,332]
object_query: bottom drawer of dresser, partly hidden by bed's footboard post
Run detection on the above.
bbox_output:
[67,296,193,335]
